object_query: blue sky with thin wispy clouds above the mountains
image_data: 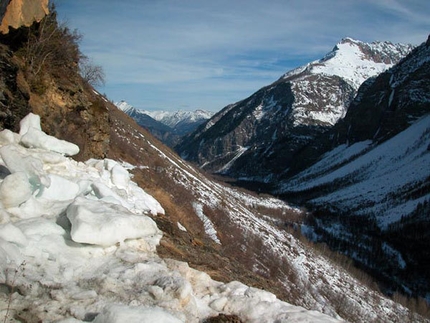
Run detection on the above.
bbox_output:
[55,0,430,111]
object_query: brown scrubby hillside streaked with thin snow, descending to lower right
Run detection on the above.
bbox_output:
[111,116,425,322]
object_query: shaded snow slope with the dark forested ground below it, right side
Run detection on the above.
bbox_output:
[277,113,430,299]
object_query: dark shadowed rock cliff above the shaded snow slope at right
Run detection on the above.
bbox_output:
[284,40,430,177]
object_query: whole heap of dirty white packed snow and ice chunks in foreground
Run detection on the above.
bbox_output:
[0,115,344,323]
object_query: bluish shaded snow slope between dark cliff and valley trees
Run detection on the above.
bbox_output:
[279,115,430,229]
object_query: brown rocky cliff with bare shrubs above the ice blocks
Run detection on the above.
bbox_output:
[0,4,110,160]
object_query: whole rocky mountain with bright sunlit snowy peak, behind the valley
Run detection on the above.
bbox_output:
[177,38,412,182]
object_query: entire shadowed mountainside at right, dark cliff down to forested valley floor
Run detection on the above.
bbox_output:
[277,41,430,297]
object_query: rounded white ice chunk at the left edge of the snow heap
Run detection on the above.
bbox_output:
[0,172,33,208]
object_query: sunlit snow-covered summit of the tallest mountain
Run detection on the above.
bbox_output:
[281,38,413,126]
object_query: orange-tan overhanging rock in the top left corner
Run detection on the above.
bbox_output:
[0,0,49,34]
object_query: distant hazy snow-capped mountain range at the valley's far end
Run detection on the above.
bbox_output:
[115,101,214,147]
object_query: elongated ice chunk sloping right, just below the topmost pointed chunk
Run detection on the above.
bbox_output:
[21,127,79,156]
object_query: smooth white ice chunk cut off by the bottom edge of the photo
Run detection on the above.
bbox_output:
[93,305,183,323]
